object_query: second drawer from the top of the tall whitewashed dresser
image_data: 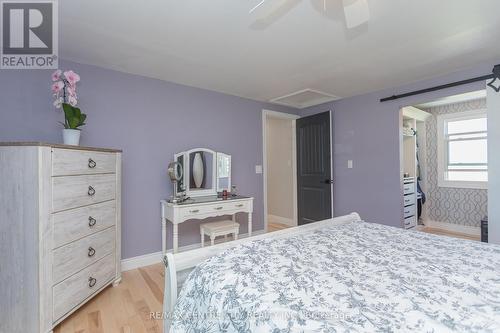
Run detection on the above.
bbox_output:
[52,174,116,212]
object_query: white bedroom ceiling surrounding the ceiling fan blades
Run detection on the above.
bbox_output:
[59,0,500,106]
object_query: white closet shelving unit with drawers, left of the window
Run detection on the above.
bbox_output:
[400,106,430,229]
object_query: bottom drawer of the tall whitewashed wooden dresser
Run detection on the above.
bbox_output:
[52,254,116,322]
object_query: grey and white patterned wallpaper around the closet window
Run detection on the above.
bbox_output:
[425,99,488,227]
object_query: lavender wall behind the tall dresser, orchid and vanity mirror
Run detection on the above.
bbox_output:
[0,61,297,258]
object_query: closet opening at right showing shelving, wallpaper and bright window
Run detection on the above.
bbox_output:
[400,90,488,240]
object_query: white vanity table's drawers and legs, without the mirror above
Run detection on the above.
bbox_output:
[161,196,253,254]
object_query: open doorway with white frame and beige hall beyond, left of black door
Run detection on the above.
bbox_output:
[262,110,299,232]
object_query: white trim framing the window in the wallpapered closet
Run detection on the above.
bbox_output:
[436,109,488,190]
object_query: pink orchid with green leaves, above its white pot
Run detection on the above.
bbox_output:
[52,69,87,129]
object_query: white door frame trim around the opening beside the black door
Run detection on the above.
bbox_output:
[262,109,300,232]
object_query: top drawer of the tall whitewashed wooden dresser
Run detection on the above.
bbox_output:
[52,149,116,176]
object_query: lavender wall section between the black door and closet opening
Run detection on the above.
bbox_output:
[300,59,500,227]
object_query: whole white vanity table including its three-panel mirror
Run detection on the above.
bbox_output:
[161,148,253,254]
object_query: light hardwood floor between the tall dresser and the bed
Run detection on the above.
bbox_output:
[54,264,164,333]
